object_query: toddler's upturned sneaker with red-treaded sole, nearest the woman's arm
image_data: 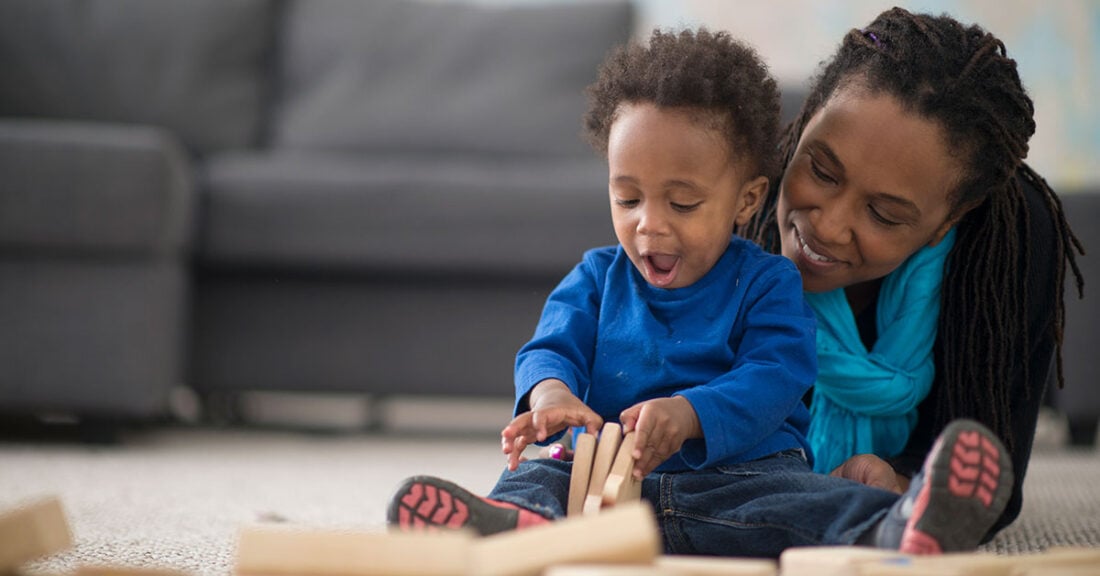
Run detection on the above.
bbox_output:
[876,420,1013,554]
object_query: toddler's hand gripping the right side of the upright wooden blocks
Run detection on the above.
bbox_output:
[619,396,703,480]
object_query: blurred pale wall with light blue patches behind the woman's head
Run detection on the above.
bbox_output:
[638,0,1100,191]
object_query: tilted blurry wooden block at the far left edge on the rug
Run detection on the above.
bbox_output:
[0,497,73,573]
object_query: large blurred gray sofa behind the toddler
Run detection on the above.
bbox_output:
[0,0,633,419]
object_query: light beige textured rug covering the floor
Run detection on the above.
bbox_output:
[0,428,1100,576]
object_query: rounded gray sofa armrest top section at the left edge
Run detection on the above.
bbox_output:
[0,119,196,256]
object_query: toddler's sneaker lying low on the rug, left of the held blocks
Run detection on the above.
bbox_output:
[386,476,549,536]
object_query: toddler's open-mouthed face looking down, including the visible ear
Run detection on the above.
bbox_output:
[607,102,767,288]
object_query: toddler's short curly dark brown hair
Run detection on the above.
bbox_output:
[584,27,779,178]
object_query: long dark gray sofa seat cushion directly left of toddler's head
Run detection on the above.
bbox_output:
[198,153,615,277]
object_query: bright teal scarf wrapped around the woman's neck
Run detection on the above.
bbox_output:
[806,230,955,474]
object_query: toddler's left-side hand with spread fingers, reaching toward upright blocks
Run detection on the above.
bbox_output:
[501,379,604,470]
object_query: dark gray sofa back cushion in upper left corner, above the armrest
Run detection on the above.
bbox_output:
[0,0,274,152]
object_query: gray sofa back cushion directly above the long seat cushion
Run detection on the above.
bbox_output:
[273,0,633,155]
